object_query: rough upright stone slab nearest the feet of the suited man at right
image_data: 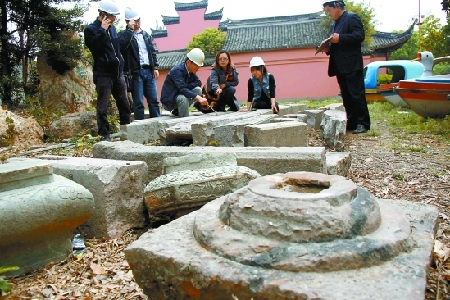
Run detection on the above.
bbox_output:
[320,110,347,151]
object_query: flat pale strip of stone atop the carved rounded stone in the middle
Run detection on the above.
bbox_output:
[163,153,237,175]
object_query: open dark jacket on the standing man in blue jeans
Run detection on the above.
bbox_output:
[118,26,159,73]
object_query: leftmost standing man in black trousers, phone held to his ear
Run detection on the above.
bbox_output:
[84,0,131,141]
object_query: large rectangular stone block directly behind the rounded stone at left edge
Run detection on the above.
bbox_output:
[40,156,148,238]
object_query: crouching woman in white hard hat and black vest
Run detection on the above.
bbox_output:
[247,56,279,114]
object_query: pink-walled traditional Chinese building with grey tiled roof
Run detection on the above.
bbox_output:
[153,0,414,102]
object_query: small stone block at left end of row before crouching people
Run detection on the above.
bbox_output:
[120,116,172,144]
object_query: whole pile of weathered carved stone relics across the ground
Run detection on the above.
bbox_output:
[0,105,437,299]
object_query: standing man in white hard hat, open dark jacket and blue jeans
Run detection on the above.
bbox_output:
[119,7,161,120]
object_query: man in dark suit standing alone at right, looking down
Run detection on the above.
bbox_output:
[323,1,370,133]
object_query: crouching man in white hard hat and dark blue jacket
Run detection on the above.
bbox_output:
[161,48,208,117]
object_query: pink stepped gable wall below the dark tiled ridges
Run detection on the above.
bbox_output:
[153,8,220,51]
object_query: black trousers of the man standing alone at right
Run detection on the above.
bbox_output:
[336,70,370,130]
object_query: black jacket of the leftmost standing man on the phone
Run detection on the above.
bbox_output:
[84,19,123,78]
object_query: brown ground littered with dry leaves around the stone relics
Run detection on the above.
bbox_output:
[0,113,450,300]
